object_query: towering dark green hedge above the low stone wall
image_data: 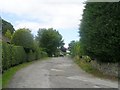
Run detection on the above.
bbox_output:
[79,2,120,62]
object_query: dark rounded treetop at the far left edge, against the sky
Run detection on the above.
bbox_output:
[2,19,15,35]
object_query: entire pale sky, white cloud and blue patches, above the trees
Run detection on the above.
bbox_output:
[0,0,85,47]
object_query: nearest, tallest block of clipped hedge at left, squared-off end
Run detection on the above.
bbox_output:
[2,42,26,71]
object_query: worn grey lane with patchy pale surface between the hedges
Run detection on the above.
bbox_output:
[9,57,118,88]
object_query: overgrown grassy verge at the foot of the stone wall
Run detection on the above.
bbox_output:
[74,59,118,81]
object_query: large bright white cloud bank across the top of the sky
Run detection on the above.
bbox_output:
[0,0,84,28]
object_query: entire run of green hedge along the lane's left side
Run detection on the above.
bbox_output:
[2,42,47,72]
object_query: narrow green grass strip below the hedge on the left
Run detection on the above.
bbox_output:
[0,58,48,88]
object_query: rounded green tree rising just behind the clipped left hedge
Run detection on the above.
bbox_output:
[11,28,34,49]
